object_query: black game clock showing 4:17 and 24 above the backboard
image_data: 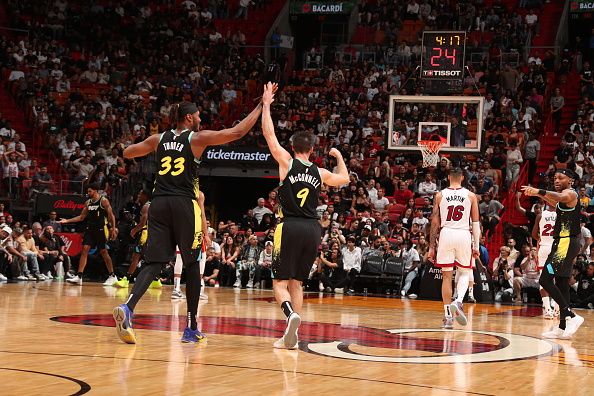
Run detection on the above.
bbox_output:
[421,31,466,80]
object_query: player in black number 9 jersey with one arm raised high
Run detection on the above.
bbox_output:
[262,83,349,349]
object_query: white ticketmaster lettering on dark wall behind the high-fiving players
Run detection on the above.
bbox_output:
[202,146,276,167]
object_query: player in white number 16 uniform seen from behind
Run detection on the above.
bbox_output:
[428,168,481,329]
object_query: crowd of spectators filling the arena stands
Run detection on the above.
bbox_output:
[0,0,594,306]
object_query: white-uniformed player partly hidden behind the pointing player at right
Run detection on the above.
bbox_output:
[532,205,557,319]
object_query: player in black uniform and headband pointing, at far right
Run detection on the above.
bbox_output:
[522,169,584,339]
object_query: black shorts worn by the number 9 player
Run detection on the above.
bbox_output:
[272,217,322,282]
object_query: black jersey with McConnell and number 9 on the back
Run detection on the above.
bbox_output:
[278,159,322,219]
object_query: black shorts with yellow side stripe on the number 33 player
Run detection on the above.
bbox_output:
[144,196,202,267]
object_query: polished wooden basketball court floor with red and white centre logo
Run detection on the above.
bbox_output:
[0,282,594,396]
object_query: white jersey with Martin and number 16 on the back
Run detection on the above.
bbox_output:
[439,188,472,230]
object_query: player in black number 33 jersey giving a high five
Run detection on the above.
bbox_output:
[113,90,262,344]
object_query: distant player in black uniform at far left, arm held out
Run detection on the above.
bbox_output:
[60,184,118,286]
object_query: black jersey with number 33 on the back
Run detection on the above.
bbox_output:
[153,129,200,199]
